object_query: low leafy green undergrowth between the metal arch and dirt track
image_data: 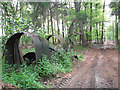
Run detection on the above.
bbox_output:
[2,50,82,88]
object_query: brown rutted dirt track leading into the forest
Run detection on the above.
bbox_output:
[52,42,118,88]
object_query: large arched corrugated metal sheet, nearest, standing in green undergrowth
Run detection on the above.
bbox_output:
[5,32,50,65]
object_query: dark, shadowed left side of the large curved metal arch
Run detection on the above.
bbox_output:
[5,33,24,64]
